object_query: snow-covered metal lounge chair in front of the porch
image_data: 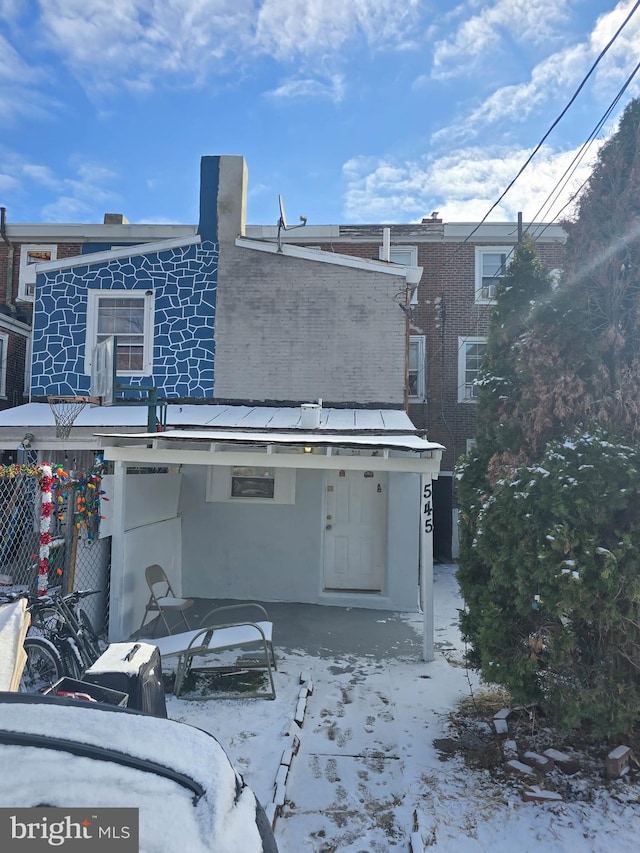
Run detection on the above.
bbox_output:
[153,602,278,699]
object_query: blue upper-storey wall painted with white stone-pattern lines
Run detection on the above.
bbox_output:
[31,240,219,398]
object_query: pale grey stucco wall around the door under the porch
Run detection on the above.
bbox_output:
[180,466,419,610]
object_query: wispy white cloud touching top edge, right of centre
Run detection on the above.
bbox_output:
[432,0,567,78]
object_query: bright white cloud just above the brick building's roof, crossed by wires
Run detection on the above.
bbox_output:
[343,146,597,222]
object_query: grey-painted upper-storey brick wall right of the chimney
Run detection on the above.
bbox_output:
[215,245,405,408]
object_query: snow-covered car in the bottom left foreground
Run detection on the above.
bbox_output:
[0,693,277,853]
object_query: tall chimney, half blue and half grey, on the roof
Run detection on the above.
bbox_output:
[198,154,247,243]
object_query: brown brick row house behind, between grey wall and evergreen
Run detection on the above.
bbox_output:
[255,218,566,561]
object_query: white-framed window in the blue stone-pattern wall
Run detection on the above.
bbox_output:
[85,290,153,376]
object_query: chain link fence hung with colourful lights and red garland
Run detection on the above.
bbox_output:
[0,465,111,632]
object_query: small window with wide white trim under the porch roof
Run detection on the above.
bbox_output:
[206,465,296,504]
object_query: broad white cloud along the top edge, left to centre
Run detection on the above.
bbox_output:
[33,0,421,90]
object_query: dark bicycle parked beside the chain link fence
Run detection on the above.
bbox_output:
[5,589,103,693]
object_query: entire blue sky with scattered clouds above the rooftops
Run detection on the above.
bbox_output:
[0,0,640,224]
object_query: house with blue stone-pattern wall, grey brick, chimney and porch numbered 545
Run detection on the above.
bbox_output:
[0,156,443,657]
